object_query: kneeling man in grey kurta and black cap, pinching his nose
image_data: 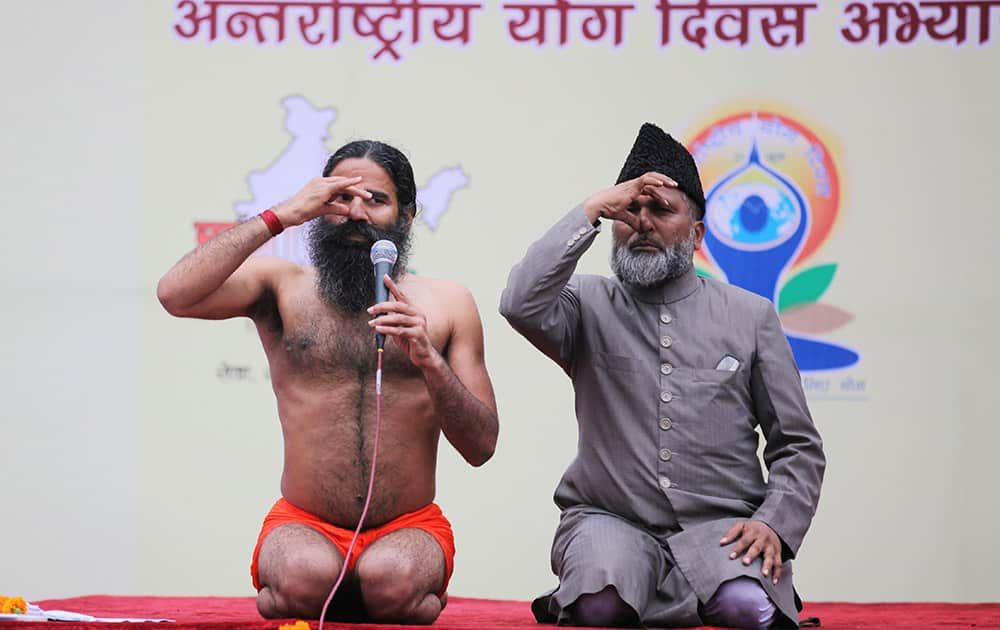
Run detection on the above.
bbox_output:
[500,124,825,628]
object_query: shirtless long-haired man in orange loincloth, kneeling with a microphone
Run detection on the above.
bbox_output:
[157,140,498,624]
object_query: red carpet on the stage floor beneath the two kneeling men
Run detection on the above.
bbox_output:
[0,595,1000,630]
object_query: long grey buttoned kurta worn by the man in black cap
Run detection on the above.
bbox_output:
[500,207,825,626]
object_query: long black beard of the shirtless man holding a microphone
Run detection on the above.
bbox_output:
[309,215,410,313]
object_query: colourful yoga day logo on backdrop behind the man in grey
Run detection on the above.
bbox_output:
[686,108,860,371]
